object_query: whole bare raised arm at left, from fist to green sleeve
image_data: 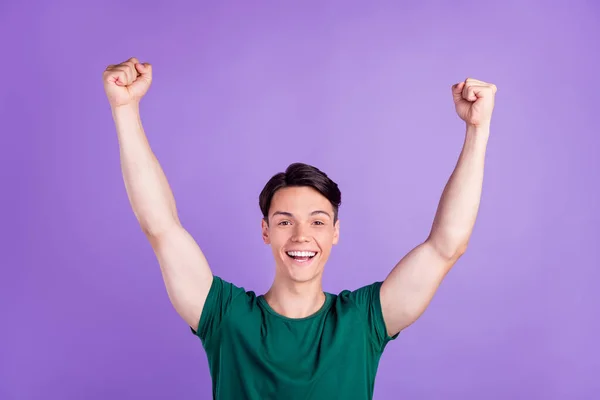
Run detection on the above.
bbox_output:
[103,58,212,329]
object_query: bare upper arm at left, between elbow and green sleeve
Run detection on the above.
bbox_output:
[149,225,213,329]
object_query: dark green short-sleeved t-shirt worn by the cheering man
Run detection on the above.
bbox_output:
[192,276,398,400]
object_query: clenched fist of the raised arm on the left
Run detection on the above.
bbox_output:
[102,57,152,108]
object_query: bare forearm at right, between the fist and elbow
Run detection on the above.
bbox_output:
[428,125,490,258]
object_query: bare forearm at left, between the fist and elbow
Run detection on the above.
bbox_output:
[113,105,179,236]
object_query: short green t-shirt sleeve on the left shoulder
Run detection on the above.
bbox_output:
[192,276,246,342]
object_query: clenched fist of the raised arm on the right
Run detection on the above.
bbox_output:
[452,78,496,126]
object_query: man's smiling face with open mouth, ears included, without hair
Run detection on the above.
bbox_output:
[262,187,339,282]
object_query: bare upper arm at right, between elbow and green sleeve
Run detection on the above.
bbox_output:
[381,242,456,335]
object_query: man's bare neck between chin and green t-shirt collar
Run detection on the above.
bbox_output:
[264,276,325,318]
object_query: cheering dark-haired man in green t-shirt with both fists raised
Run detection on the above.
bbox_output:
[103,58,496,400]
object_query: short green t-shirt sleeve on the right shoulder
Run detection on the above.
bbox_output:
[349,282,399,351]
